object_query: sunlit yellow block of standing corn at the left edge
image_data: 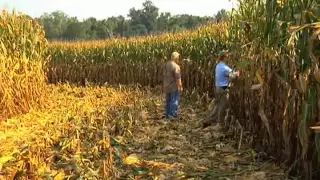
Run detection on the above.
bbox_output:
[0,11,47,120]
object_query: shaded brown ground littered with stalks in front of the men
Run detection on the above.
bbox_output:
[123,95,285,180]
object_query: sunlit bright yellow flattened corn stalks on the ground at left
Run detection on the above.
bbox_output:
[0,84,152,180]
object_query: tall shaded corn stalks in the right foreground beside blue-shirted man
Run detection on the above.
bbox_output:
[229,0,320,179]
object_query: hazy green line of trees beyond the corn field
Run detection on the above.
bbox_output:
[37,0,228,40]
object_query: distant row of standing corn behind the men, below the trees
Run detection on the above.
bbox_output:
[48,24,226,91]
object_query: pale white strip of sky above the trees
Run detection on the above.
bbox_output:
[0,0,232,20]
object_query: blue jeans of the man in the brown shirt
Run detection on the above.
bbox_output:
[165,90,180,119]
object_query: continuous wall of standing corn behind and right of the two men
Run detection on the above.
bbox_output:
[48,0,320,179]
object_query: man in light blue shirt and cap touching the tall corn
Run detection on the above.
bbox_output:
[203,51,240,128]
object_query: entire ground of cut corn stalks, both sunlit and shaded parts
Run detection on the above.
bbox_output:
[0,84,286,180]
